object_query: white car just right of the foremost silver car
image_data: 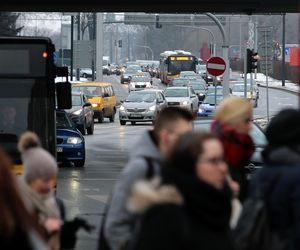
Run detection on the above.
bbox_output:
[164,86,198,114]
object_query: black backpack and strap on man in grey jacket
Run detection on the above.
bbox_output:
[98,157,155,250]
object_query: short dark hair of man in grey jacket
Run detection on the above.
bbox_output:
[153,107,194,139]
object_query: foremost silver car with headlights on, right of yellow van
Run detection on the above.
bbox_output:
[119,89,167,125]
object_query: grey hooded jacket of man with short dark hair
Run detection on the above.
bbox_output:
[104,131,161,250]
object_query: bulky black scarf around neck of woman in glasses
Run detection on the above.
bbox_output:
[163,167,232,230]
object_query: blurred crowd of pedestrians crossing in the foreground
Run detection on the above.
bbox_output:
[0,97,300,250]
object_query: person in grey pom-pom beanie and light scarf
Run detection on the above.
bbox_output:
[18,132,62,250]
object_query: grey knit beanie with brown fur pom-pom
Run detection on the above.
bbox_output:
[18,132,57,183]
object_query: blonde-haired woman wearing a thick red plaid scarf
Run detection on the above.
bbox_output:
[211,96,255,201]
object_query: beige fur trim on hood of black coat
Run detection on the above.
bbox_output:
[127,178,183,214]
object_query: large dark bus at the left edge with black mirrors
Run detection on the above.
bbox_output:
[0,37,72,174]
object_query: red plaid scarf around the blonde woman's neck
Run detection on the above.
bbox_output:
[211,121,255,171]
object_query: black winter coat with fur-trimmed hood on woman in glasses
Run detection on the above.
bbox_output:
[128,166,234,250]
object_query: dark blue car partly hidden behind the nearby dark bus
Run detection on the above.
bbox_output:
[56,110,85,167]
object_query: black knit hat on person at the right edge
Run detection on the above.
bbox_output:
[266,109,300,147]
